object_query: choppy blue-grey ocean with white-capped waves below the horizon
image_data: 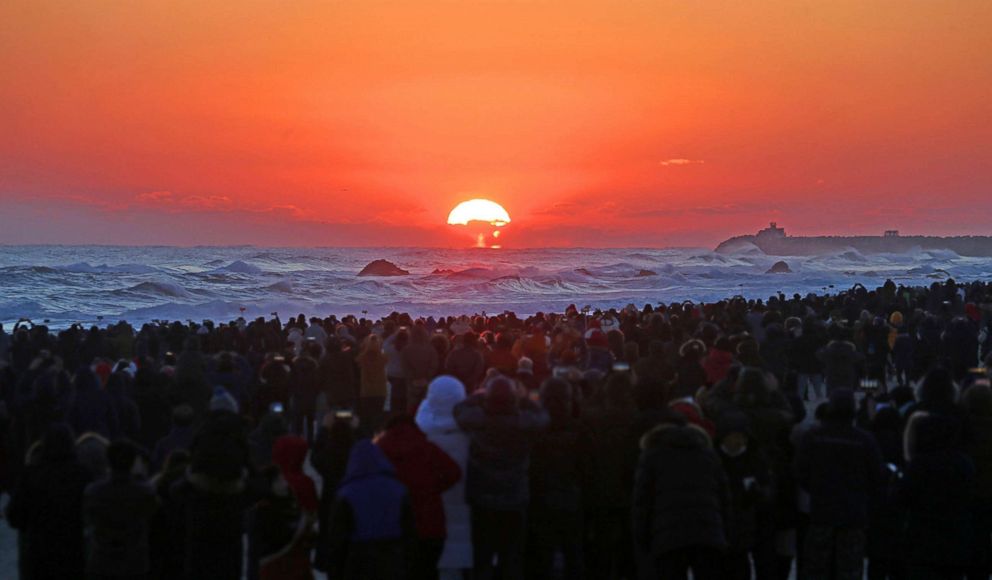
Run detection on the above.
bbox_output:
[0,245,992,330]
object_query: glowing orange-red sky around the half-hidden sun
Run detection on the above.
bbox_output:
[0,0,992,246]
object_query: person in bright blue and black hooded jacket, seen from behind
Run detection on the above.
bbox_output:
[327,439,417,580]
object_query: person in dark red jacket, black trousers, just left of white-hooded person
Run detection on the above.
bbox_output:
[375,414,462,580]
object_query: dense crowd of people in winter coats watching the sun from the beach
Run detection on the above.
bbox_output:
[0,281,992,580]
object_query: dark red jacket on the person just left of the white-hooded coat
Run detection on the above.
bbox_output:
[376,419,462,539]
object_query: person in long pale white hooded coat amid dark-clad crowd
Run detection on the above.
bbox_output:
[416,375,472,580]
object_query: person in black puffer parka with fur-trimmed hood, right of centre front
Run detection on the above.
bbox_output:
[633,413,730,580]
